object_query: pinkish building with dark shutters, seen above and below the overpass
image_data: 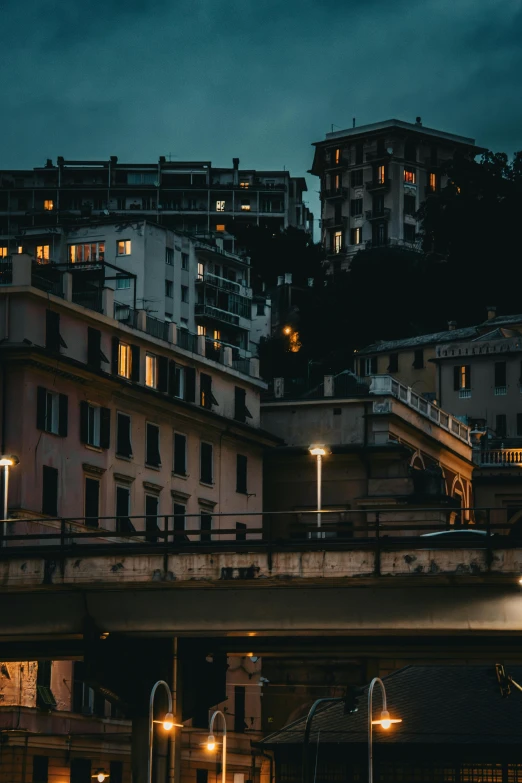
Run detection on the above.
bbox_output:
[0,254,277,783]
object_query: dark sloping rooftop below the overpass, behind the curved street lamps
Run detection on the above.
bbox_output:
[258,664,522,748]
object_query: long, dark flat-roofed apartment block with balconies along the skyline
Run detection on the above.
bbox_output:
[0,156,313,258]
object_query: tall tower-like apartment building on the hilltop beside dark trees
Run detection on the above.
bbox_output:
[311,117,483,271]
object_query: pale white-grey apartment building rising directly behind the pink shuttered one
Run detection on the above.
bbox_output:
[11,216,269,360]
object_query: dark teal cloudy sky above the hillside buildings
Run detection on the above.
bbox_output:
[0,0,522,224]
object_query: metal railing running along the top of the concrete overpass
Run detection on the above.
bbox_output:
[0,508,522,564]
